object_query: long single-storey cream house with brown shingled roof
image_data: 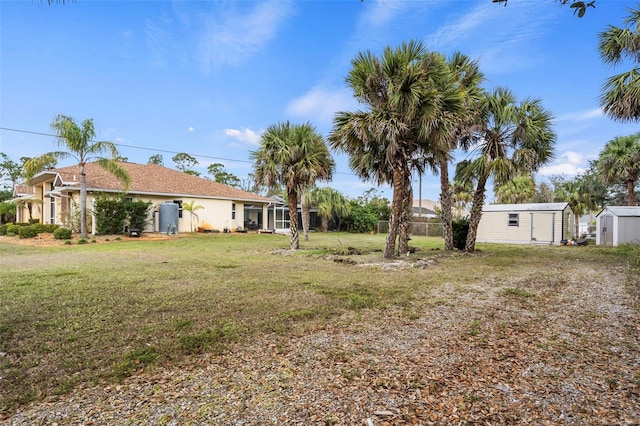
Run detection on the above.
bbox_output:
[15,162,273,234]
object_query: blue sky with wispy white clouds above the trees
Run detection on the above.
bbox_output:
[0,0,638,200]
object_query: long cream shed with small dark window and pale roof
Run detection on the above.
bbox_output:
[476,203,574,245]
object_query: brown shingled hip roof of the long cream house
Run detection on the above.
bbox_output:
[43,162,272,203]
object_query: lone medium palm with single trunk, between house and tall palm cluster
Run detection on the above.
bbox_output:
[251,121,335,250]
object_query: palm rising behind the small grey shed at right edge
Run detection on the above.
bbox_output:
[598,132,640,206]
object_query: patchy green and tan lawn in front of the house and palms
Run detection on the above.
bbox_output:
[0,234,640,417]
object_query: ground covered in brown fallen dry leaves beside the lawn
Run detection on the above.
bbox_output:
[6,256,640,425]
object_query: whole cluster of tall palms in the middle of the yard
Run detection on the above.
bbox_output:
[329,41,555,258]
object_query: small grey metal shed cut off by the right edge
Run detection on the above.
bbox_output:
[596,206,640,246]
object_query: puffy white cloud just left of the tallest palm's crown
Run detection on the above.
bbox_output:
[286,88,357,124]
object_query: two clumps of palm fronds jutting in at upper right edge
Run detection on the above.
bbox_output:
[598,8,640,122]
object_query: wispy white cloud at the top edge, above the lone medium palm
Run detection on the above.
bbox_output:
[200,1,293,71]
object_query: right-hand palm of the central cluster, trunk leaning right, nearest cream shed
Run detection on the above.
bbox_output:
[463,88,556,252]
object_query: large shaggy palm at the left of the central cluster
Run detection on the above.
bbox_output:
[329,41,456,259]
